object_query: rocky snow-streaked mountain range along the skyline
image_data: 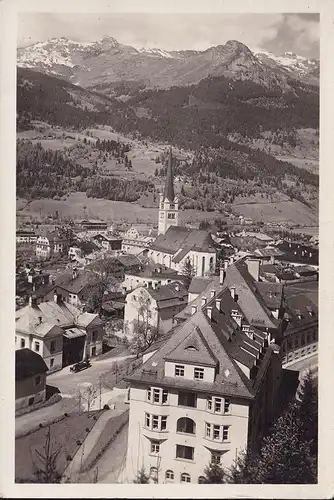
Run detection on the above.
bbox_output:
[17,37,319,96]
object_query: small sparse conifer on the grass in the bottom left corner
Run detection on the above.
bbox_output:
[33,425,62,483]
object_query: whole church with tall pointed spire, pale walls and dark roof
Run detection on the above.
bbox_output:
[149,148,216,276]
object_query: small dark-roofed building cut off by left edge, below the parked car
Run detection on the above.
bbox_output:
[15,348,48,410]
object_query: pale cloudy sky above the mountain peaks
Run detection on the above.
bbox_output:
[18,13,319,58]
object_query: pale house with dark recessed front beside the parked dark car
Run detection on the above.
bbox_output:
[15,294,104,371]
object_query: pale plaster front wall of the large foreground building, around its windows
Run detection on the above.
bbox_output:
[127,387,249,483]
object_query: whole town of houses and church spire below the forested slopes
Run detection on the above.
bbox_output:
[15,148,319,483]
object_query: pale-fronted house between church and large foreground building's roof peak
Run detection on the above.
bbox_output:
[124,282,188,337]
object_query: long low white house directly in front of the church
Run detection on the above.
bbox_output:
[122,264,182,292]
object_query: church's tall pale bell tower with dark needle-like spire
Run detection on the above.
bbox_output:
[158,147,179,234]
